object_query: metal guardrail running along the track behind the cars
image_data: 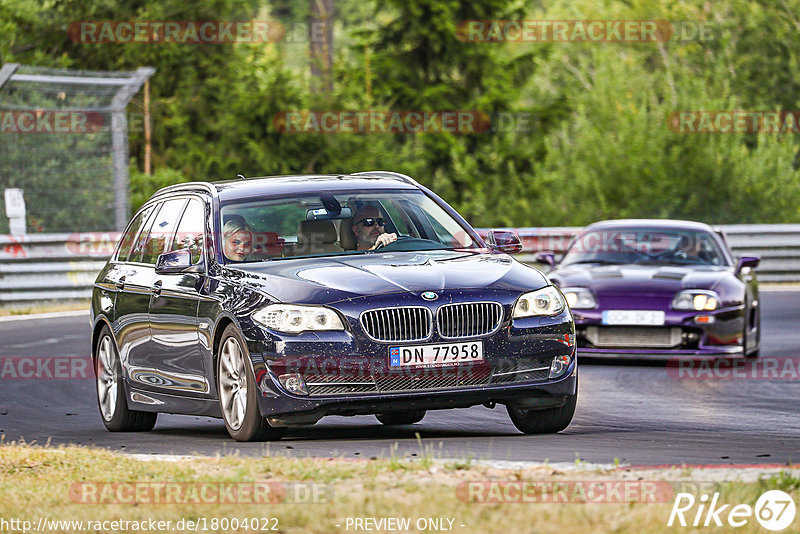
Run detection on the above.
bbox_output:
[0,224,800,307]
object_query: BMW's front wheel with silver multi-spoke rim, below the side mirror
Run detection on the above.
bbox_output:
[217,324,286,441]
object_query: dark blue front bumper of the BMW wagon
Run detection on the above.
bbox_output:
[245,295,577,425]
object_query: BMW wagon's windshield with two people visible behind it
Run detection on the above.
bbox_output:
[221,191,477,263]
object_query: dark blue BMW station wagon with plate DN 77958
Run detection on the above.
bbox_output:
[91,171,578,441]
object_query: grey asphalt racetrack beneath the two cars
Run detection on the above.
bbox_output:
[0,291,800,465]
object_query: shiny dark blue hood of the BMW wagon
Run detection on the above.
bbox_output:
[224,251,549,304]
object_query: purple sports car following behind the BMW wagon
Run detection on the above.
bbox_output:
[537,220,760,358]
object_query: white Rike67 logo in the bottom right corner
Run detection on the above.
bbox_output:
[667,490,796,532]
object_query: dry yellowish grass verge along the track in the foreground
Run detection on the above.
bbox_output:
[0,444,800,534]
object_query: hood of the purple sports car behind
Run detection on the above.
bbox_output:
[548,264,733,294]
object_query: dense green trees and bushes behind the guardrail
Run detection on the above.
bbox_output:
[0,0,800,230]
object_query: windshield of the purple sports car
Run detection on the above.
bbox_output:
[561,229,728,265]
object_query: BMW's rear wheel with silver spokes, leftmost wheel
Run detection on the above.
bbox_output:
[94,326,158,432]
